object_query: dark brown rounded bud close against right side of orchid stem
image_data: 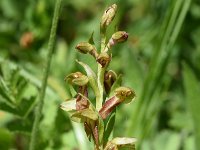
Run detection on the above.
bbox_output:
[104,70,117,93]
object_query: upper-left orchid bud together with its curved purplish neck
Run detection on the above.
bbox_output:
[76,42,98,59]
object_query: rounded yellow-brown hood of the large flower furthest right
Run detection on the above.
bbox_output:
[115,87,135,103]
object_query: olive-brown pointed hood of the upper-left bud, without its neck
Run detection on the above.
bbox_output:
[75,42,95,54]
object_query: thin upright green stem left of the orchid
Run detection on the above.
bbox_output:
[29,0,62,150]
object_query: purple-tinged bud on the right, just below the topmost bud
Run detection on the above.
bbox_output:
[109,31,128,46]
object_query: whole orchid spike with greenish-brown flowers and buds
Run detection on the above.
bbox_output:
[61,4,136,150]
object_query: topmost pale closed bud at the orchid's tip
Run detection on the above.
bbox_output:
[101,4,117,29]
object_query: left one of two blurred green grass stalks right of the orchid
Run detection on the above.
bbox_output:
[127,0,182,135]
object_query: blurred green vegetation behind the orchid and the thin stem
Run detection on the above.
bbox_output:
[0,0,200,150]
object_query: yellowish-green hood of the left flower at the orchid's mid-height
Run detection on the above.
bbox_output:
[65,72,89,86]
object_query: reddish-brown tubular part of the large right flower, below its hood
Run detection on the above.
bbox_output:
[99,96,120,119]
